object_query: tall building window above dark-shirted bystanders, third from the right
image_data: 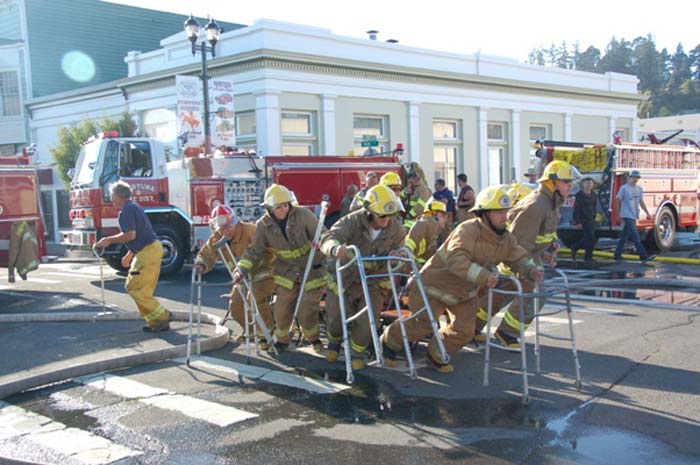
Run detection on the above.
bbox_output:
[433,120,462,192]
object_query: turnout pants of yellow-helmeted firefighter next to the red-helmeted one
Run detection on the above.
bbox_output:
[272,283,324,344]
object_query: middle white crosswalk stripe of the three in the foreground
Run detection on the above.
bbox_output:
[75,374,258,426]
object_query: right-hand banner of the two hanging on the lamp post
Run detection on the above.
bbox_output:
[209,79,236,147]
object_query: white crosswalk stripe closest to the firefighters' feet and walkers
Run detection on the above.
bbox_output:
[176,356,349,394]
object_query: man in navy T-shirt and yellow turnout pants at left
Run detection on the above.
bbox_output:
[96,181,170,333]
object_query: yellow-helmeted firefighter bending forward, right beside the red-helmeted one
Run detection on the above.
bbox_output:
[234,184,326,353]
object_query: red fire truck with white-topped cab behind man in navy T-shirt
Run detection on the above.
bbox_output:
[62,132,400,274]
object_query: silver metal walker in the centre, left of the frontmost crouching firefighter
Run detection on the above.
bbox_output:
[336,245,449,384]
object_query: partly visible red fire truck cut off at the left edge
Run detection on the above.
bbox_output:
[0,149,47,267]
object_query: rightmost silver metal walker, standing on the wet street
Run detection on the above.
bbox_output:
[483,270,581,405]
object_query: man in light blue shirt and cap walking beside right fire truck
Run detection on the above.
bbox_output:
[615,170,654,261]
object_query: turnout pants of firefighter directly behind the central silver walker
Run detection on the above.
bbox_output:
[326,282,388,357]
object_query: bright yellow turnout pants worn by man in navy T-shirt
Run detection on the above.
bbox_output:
[125,241,170,328]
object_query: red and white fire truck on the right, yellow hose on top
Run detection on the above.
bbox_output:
[537,141,700,251]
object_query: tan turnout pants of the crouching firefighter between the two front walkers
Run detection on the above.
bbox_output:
[383,286,478,360]
